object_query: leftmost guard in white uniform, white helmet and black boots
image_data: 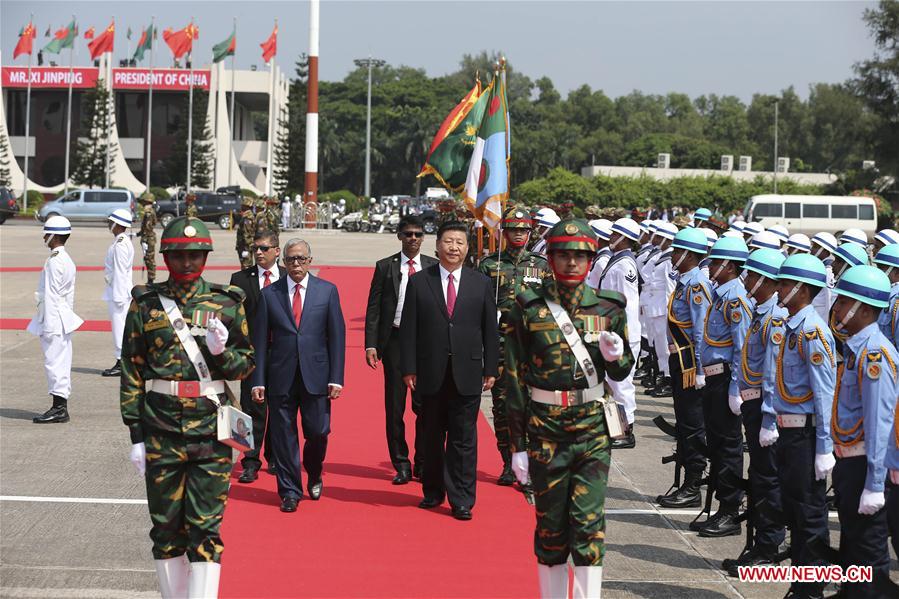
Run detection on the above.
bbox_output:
[27,216,84,424]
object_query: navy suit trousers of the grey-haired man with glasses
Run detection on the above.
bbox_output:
[269,367,331,499]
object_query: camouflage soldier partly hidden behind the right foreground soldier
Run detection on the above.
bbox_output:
[478,206,552,486]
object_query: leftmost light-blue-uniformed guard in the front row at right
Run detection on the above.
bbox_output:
[658,227,712,508]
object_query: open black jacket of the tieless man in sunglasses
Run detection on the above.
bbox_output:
[365,252,437,355]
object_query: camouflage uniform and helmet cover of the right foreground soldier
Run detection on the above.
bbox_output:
[505,219,634,566]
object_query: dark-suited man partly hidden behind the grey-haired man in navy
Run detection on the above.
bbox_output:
[231,230,287,483]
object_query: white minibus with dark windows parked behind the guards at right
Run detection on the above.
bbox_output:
[744,194,877,238]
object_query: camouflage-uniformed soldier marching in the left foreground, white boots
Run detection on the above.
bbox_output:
[121,217,255,597]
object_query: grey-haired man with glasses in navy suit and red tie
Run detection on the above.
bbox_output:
[252,239,346,512]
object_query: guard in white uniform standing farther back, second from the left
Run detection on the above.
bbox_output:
[102,208,134,376]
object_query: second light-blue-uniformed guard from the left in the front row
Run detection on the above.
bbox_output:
[691,237,754,537]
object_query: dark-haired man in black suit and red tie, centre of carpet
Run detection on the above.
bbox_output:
[400,221,499,520]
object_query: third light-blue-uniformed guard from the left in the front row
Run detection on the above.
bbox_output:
[722,249,788,576]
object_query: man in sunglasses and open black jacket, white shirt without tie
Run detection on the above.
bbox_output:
[365,216,437,485]
